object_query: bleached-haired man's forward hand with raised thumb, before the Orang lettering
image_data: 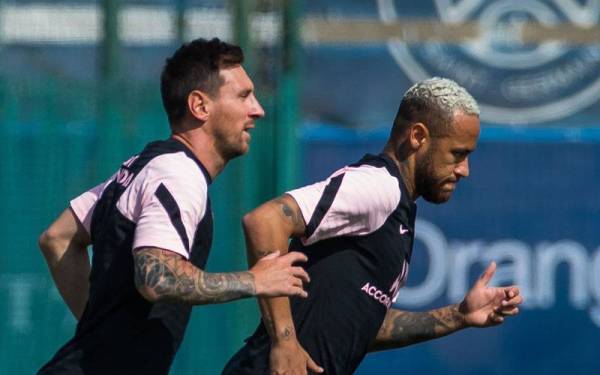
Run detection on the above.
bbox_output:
[459,262,523,327]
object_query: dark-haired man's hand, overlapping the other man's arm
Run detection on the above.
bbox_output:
[250,251,310,298]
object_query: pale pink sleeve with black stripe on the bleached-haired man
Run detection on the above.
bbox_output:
[287,165,400,245]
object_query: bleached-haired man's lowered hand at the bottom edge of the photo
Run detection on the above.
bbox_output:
[269,338,323,375]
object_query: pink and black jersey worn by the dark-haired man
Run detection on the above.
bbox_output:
[39,139,212,374]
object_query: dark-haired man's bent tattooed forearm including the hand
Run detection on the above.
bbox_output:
[133,248,308,305]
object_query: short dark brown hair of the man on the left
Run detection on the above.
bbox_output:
[160,38,244,126]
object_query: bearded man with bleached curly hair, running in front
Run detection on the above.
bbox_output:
[223,78,522,375]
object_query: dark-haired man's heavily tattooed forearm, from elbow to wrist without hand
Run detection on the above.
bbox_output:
[134,249,256,304]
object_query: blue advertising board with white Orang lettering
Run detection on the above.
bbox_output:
[303,128,600,374]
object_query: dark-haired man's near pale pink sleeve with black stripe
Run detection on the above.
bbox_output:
[129,155,208,259]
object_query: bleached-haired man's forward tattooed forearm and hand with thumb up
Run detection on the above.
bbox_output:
[370,262,523,351]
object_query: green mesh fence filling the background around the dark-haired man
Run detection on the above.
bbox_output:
[0,0,297,374]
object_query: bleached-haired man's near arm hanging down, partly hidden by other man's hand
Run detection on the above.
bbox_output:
[243,195,322,374]
